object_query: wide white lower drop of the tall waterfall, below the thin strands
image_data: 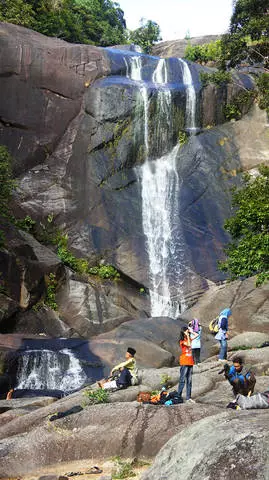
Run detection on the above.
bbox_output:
[141,145,184,318]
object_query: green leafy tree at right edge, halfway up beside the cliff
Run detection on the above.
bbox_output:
[219,165,269,285]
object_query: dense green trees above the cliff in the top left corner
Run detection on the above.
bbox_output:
[0,0,126,46]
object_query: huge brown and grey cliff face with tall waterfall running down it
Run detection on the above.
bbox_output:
[0,24,269,334]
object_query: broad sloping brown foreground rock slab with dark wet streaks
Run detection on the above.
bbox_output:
[0,402,218,477]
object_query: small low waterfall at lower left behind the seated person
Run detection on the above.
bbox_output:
[16,348,87,392]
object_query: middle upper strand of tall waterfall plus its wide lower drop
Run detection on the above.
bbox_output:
[138,59,184,318]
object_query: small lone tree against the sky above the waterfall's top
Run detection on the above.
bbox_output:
[130,18,162,53]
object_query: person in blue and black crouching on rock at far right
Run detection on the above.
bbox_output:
[220,357,256,396]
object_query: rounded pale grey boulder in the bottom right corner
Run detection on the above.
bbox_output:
[142,410,269,480]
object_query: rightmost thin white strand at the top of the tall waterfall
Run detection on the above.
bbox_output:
[178,58,196,130]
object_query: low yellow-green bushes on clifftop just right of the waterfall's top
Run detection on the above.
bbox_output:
[184,40,222,63]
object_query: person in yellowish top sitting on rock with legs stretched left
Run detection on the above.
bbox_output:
[98,347,138,390]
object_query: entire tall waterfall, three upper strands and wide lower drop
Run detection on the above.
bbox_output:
[125,56,196,318]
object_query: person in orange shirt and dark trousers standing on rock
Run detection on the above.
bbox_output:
[178,327,195,403]
